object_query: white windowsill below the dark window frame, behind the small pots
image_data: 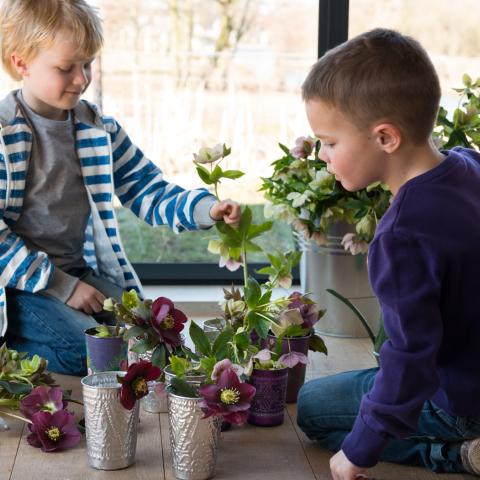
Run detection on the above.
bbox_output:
[143,285,300,317]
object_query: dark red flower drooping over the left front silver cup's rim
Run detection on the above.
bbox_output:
[117,360,162,410]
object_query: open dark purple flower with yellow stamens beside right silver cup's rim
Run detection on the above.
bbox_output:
[198,361,255,425]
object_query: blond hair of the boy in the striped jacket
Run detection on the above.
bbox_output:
[0,0,103,80]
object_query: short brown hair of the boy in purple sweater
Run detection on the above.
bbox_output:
[302,28,441,144]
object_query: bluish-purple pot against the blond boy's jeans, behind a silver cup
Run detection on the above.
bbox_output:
[85,327,127,375]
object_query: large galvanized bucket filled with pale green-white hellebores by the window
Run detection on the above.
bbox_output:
[262,137,391,336]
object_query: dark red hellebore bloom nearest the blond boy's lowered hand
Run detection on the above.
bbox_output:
[151,297,187,347]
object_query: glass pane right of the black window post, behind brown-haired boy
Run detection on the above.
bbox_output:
[349,0,480,112]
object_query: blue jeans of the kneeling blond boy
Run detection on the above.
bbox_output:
[5,273,122,375]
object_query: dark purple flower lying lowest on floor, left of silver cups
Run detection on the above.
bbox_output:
[27,410,81,452]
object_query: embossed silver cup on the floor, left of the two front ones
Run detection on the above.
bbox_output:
[82,372,139,470]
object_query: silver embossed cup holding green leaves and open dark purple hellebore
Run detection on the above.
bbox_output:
[166,322,255,480]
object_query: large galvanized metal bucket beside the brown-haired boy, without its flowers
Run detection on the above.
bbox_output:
[297,223,380,337]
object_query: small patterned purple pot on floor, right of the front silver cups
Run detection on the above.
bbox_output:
[248,368,288,427]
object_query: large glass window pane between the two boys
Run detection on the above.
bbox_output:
[89,0,319,262]
